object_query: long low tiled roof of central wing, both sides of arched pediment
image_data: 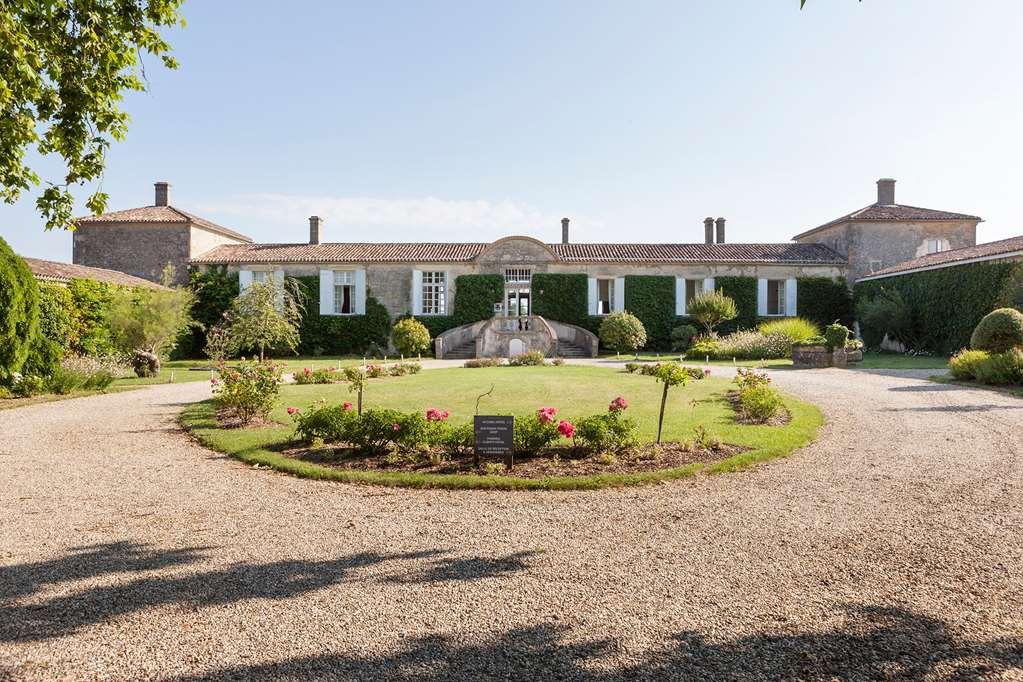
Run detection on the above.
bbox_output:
[192,242,846,265]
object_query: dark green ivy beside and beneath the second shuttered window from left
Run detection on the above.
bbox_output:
[295,275,391,355]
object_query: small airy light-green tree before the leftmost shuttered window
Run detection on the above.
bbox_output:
[228,279,303,360]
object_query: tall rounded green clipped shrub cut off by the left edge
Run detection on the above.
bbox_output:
[0,237,39,384]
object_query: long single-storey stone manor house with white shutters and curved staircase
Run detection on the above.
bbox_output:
[74,179,981,357]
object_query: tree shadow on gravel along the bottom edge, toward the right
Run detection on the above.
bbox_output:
[169,606,1023,682]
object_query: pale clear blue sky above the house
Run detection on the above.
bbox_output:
[0,0,1023,260]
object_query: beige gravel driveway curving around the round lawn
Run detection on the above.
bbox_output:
[0,370,1023,680]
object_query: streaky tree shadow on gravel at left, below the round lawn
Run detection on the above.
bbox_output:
[0,542,533,642]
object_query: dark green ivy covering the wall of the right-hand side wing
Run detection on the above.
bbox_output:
[854,263,1016,354]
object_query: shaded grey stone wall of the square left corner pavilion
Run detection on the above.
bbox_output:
[72,223,191,283]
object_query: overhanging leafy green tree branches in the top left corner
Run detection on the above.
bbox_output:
[0,0,184,229]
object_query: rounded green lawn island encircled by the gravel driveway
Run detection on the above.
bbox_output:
[182,365,822,489]
